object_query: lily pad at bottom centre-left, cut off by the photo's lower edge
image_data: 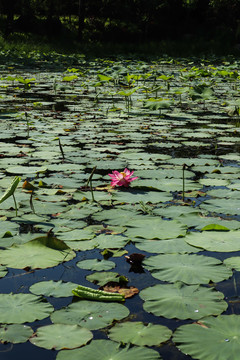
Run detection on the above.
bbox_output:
[56,340,162,360]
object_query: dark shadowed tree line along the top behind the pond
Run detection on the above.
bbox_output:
[0,0,240,43]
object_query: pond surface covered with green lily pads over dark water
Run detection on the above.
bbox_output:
[0,56,240,360]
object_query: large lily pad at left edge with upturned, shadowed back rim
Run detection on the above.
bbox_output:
[0,236,76,269]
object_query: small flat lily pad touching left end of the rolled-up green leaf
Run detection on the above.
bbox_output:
[29,280,78,297]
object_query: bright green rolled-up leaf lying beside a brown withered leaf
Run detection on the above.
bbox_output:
[72,285,125,301]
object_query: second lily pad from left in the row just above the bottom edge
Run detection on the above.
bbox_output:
[30,324,93,350]
